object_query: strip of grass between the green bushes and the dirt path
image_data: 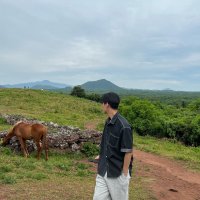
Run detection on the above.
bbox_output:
[134,134,200,171]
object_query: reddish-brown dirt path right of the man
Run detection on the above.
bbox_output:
[134,150,200,200]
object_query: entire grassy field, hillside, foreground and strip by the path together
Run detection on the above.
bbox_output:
[0,89,200,200]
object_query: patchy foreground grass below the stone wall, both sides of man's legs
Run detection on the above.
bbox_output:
[0,147,154,200]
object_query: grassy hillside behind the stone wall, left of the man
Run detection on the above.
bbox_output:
[0,89,105,128]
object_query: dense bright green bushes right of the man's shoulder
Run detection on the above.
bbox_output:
[120,97,200,146]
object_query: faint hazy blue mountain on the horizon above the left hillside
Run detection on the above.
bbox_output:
[3,80,69,89]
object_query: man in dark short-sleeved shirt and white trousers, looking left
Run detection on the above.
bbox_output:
[93,92,133,200]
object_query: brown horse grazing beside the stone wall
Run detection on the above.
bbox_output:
[2,121,48,160]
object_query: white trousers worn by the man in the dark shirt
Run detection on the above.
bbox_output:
[93,173,130,200]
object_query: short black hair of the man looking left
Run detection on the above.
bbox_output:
[101,92,120,109]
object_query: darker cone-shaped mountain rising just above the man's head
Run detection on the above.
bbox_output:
[81,79,126,92]
